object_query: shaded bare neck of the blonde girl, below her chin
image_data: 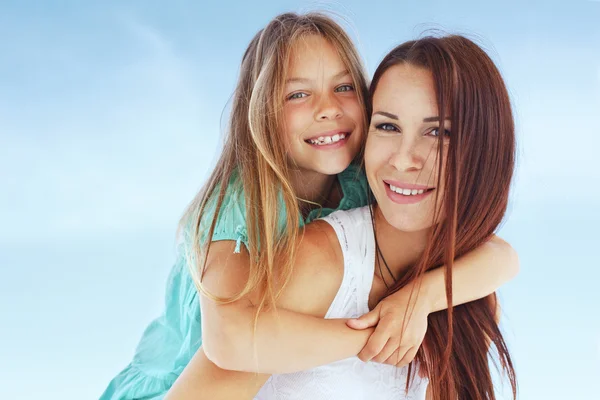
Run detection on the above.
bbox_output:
[290,169,341,216]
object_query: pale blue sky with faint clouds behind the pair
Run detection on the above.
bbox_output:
[0,0,600,400]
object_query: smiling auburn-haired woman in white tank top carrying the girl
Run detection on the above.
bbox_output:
[168,36,516,400]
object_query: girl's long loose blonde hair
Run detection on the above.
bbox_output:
[180,12,368,310]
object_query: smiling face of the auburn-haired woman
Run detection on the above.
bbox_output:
[365,64,451,232]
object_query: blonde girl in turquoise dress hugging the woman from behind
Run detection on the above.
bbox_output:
[102,14,516,399]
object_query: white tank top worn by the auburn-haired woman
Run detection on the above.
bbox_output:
[255,207,428,400]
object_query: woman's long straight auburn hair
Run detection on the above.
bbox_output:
[369,35,517,400]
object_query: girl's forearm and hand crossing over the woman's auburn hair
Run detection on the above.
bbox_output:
[348,236,519,366]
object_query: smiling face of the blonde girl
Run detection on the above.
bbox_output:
[283,35,364,175]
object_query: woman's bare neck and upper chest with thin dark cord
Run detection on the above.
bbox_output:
[373,205,430,282]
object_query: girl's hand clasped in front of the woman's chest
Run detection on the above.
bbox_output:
[346,285,430,367]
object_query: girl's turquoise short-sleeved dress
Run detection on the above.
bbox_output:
[100,165,367,400]
